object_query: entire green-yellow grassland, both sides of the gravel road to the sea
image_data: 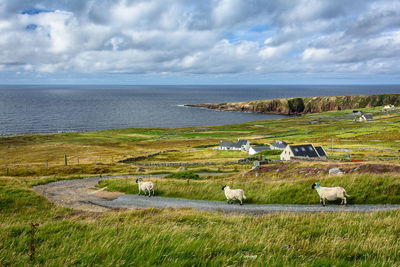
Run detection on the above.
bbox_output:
[0,108,400,266]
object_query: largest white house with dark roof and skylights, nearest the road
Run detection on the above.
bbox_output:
[281,144,327,160]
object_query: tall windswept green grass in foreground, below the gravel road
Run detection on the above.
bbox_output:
[0,179,400,266]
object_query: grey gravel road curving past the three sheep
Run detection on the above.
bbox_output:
[33,175,400,215]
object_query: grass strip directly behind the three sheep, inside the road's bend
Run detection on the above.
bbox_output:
[100,173,400,204]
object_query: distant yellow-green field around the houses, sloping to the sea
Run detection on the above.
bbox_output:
[0,108,400,178]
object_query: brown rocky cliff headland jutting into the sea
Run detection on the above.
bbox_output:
[187,94,400,115]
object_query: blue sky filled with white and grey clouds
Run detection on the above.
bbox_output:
[0,0,400,84]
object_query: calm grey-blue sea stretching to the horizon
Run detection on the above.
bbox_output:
[0,85,400,134]
